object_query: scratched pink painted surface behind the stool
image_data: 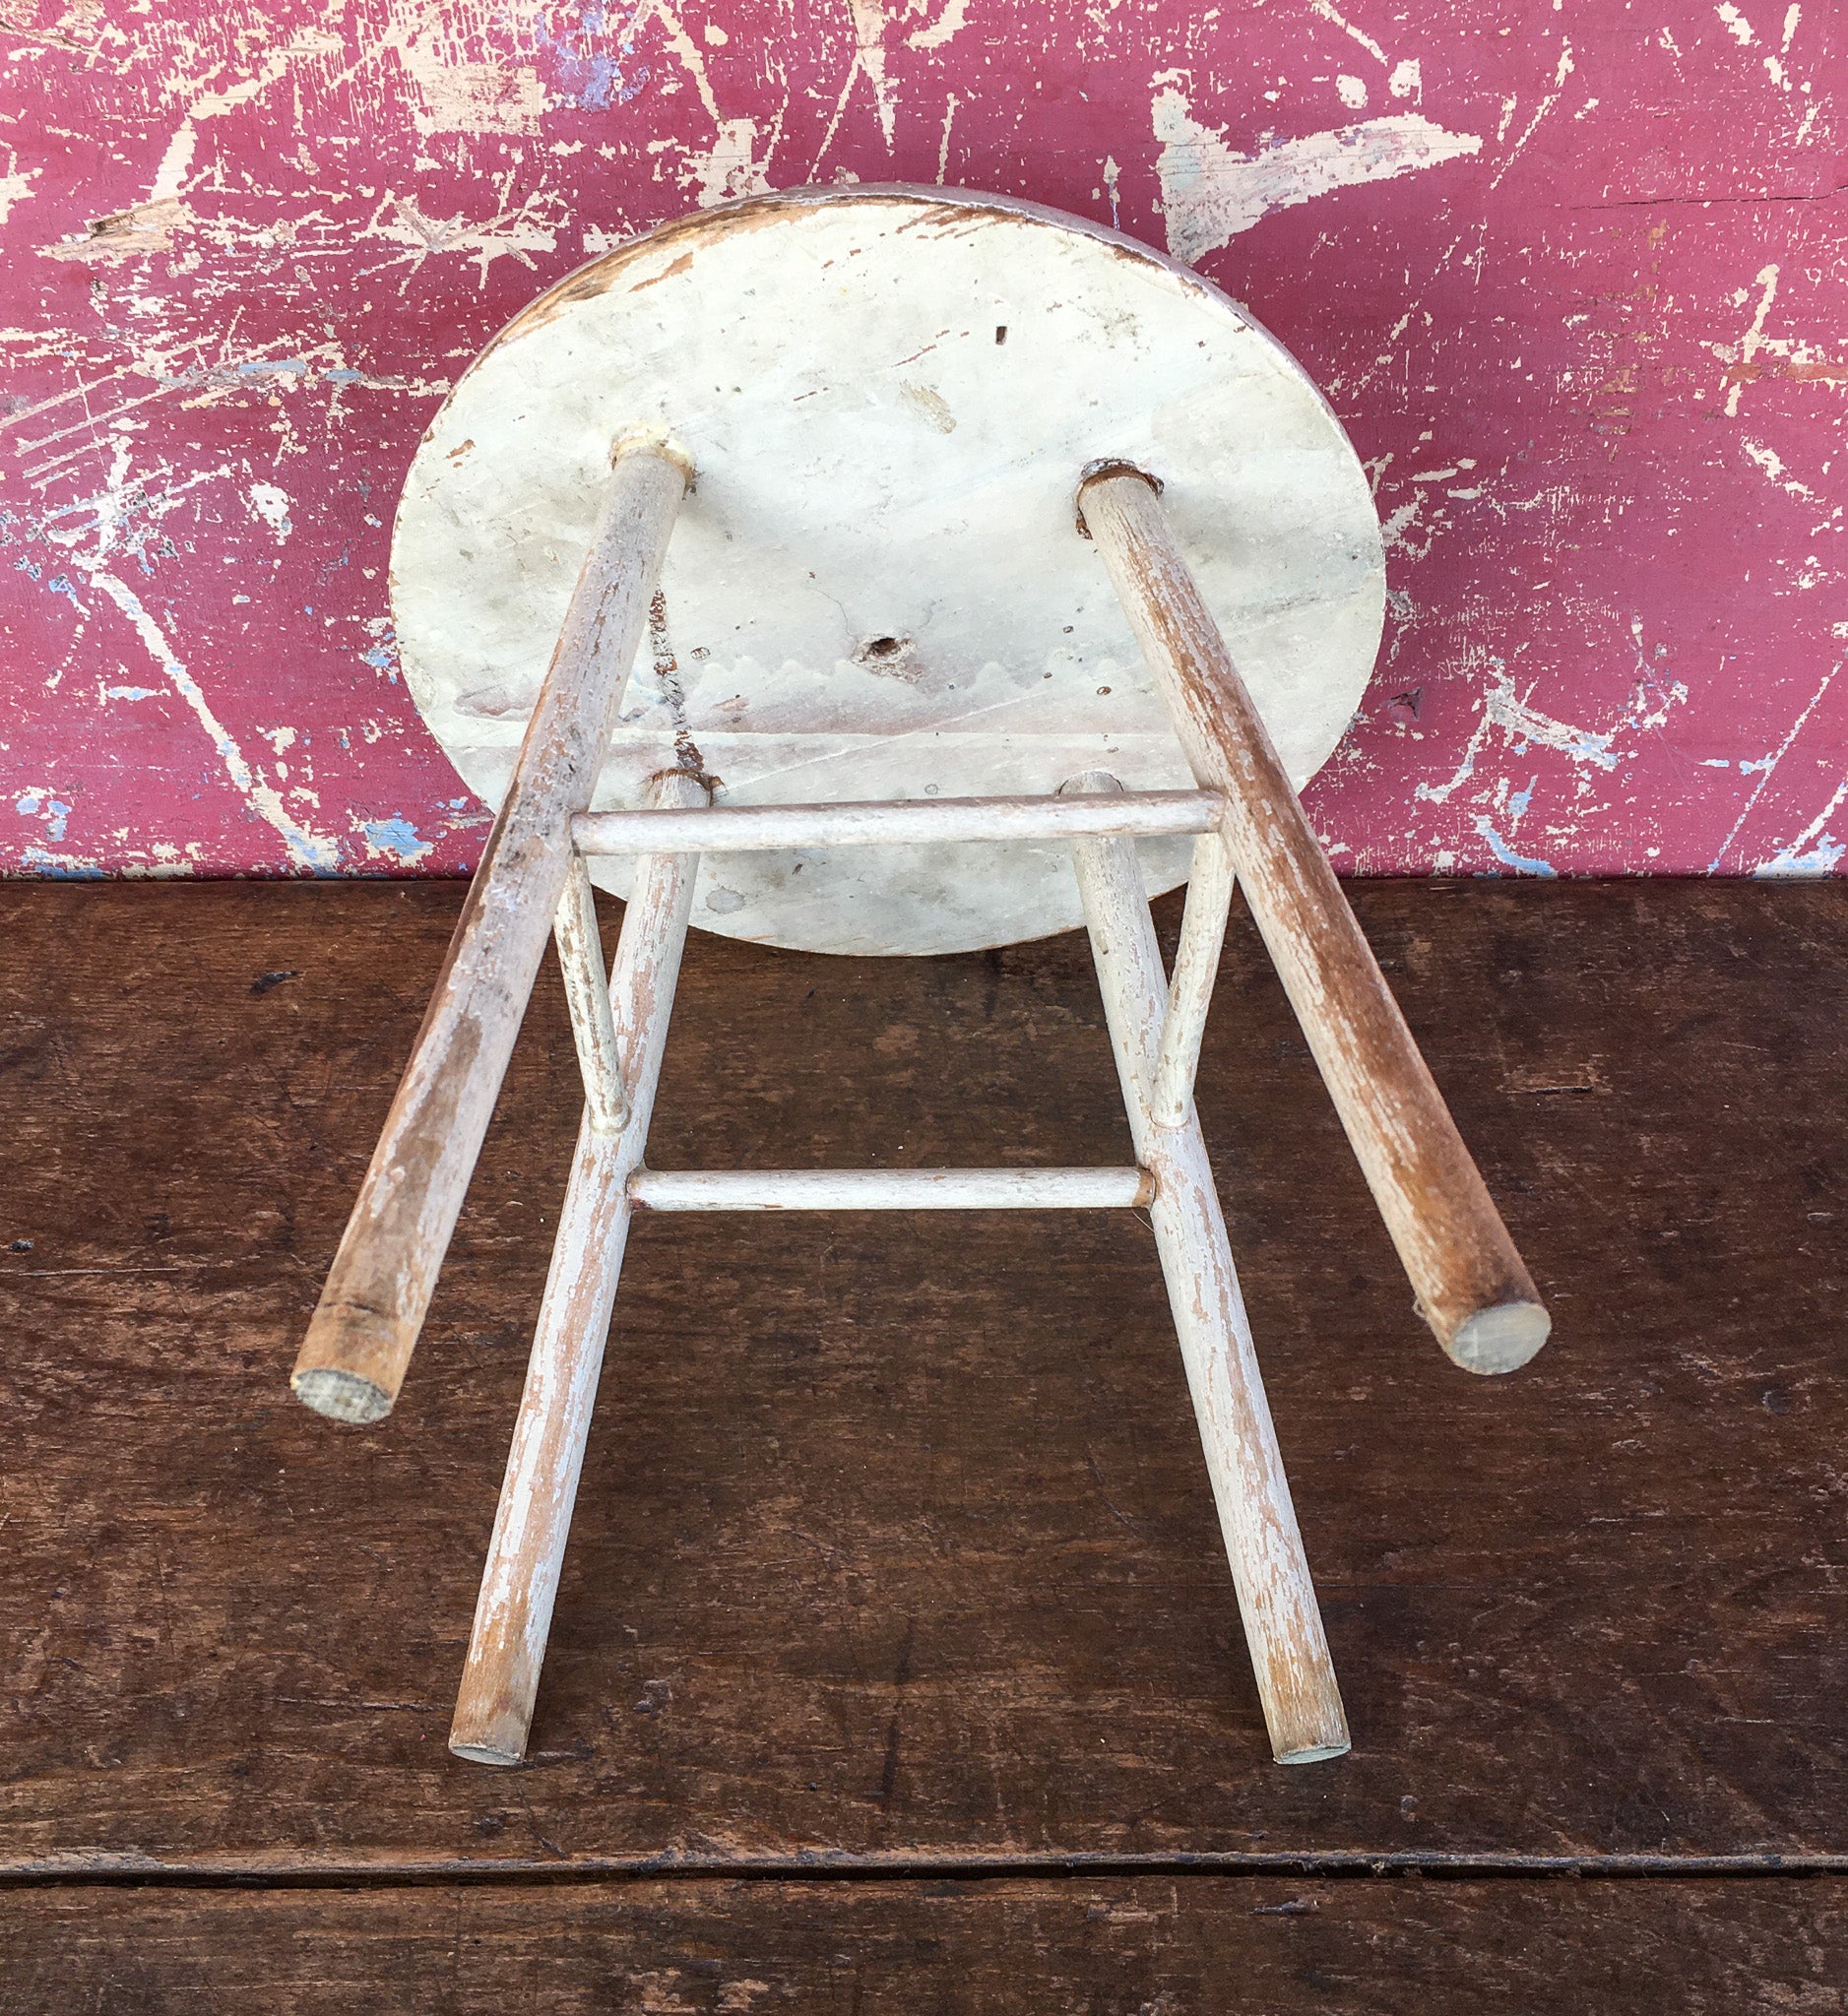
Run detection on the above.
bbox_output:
[0,0,1848,875]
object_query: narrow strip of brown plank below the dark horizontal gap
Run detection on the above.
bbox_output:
[0,1877,1848,2016]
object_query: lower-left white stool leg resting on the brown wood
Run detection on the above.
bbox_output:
[449,776,705,1764]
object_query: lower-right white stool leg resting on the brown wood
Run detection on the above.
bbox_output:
[1064,772,1348,1764]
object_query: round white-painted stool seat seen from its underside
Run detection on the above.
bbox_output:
[391,187,1384,954]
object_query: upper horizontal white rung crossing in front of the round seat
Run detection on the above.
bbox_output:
[572,790,1221,854]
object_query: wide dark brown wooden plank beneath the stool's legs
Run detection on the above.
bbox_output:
[0,883,1848,1866]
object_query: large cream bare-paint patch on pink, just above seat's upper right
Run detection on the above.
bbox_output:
[1151,85,1481,262]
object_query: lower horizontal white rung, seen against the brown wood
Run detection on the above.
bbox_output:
[629,1169,1155,1212]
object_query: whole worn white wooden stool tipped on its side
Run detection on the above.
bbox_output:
[294,187,1548,1764]
